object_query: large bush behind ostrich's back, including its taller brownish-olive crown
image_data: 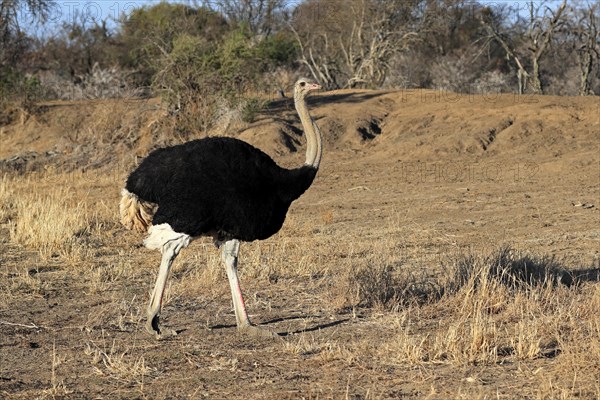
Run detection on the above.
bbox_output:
[115,3,297,135]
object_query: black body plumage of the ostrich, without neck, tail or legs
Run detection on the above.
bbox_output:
[125,137,317,241]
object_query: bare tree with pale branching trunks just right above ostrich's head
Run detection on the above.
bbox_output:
[290,0,419,87]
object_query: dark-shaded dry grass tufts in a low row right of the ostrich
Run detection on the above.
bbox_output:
[337,247,574,310]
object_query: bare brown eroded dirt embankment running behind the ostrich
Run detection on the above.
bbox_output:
[0,90,600,169]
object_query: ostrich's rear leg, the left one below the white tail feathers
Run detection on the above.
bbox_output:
[146,239,187,339]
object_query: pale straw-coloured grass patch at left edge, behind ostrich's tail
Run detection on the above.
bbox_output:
[0,170,124,265]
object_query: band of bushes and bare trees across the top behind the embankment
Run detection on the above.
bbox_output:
[0,0,600,132]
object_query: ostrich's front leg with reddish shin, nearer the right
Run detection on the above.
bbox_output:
[222,239,279,337]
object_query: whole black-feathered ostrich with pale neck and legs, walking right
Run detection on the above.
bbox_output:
[119,78,322,339]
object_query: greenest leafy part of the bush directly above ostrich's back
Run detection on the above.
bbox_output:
[153,27,286,134]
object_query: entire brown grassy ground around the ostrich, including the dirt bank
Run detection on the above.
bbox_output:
[0,90,600,399]
